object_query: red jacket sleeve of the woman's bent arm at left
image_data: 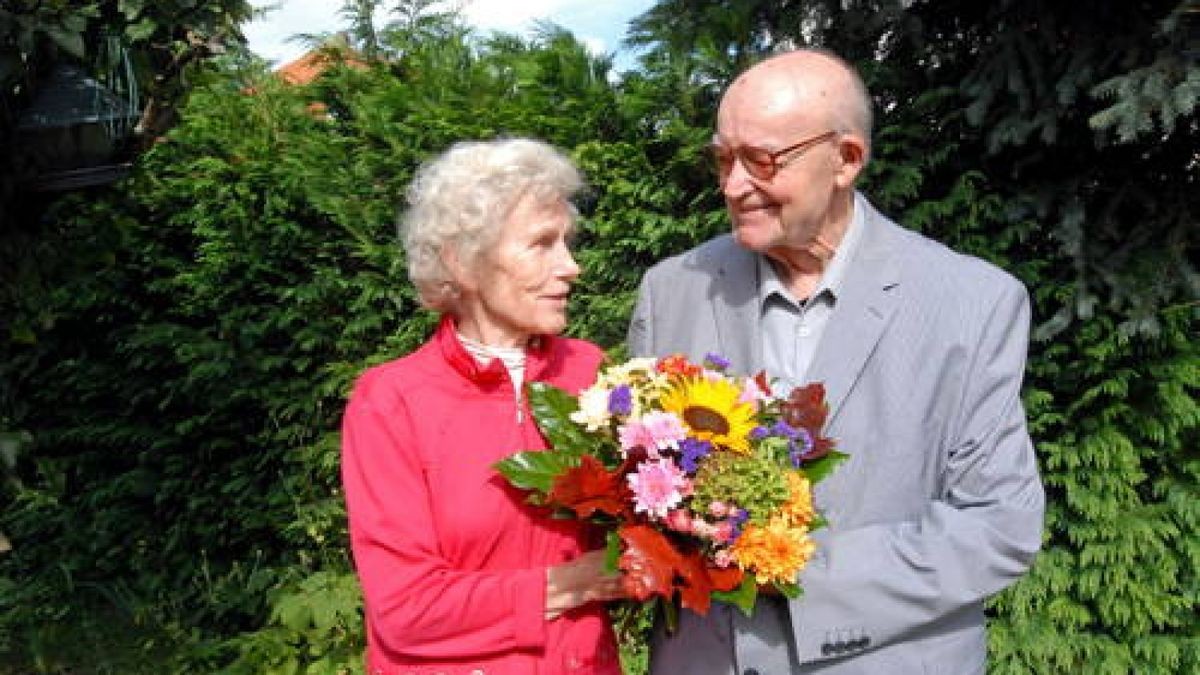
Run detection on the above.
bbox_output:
[342,381,546,659]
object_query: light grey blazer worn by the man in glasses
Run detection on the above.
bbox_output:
[629,196,1044,675]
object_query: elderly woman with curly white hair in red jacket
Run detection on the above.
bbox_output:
[342,139,622,675]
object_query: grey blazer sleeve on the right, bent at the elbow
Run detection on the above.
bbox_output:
[792,276,1044,662]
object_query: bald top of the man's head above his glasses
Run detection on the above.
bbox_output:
[718,49,871,159]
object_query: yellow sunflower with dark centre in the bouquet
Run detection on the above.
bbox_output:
[660,377,755,454]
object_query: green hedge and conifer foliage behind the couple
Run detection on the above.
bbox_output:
[0,0,1200,674]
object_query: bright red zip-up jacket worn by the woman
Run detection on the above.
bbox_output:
[342,319,620,675]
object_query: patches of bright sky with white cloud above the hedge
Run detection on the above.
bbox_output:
[242,0,654,71]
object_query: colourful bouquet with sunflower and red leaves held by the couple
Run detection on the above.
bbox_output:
[497,354,846,625]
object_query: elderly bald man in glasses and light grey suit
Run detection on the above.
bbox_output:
[629,50,1044,675]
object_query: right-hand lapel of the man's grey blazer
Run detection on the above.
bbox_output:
[806,198,899,424]
